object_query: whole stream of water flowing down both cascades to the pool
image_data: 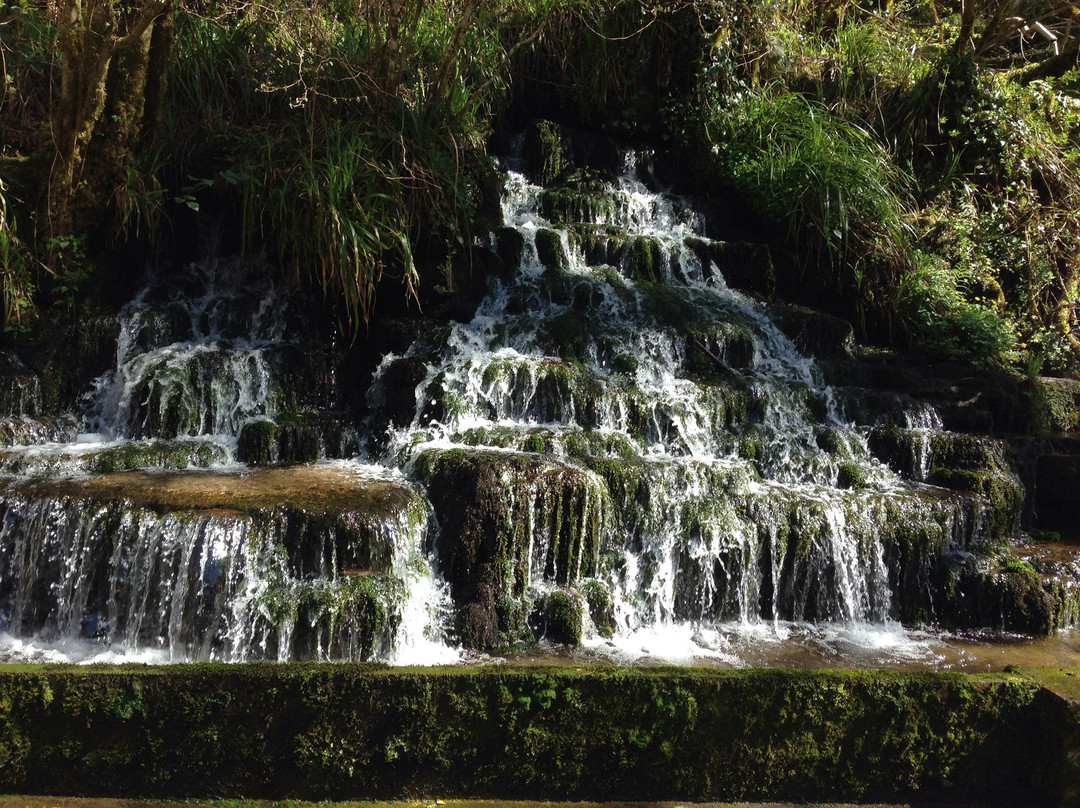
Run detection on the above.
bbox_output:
[0,139,1080,669]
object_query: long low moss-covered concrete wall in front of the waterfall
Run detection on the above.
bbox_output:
[0,664,1077,805]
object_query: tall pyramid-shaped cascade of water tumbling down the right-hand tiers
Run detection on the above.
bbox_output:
[370,139,1045,661]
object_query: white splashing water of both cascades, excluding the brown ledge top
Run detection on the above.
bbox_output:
[0,141,1028,665]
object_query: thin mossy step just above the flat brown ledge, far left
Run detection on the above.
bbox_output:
[0,440,229,476]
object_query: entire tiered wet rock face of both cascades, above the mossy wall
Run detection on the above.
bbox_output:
[0,118,1080,661]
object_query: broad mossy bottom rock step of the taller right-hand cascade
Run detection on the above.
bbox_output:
[413,447,1080,648]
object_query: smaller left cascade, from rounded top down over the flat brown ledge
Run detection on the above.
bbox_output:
[0,260,457,663]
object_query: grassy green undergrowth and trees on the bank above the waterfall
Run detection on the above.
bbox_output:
[0,0,1080,376]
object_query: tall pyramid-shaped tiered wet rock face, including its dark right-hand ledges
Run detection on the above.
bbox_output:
[376,125,1074,648]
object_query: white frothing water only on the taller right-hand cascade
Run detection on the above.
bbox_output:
[356,144,1002,664]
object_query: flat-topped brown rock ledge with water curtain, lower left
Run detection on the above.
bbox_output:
[0,467,428,661]
